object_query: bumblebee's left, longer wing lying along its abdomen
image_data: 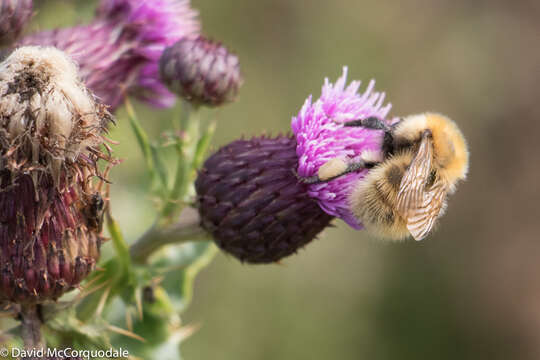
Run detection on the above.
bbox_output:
[397,136,433,219]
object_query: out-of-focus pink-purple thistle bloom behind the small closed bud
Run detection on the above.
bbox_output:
[21,0,200,110]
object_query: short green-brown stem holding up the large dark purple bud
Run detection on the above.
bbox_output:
[130,207,208,264]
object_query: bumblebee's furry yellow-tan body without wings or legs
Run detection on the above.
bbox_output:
[349,113,469,239]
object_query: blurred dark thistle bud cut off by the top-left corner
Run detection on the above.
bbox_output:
[0,0,33,46]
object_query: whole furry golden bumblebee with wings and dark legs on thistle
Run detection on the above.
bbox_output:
[299,113,469,240]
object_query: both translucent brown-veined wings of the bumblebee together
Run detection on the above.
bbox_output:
[397,136,448,240]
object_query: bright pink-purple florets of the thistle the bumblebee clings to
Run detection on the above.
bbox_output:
[291,67,391,229]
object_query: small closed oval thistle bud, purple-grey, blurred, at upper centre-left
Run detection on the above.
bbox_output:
[160,36,242,106]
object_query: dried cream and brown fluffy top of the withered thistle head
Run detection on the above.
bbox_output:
[0,46,112,185]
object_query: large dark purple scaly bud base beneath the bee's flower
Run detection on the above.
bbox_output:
[195,136,332,263]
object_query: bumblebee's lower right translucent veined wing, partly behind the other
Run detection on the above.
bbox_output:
[407,180,448,240]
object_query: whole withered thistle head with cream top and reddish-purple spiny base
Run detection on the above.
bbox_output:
[0,47,112,303]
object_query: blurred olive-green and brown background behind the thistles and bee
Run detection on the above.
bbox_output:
[33,0,540,360]
